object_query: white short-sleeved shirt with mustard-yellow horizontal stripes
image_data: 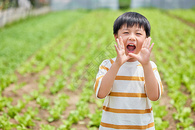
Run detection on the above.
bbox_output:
[94,58,163,130]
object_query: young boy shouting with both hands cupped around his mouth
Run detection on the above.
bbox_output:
[94,12,163,130]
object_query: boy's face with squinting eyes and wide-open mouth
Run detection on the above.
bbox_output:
[114,24,146,61]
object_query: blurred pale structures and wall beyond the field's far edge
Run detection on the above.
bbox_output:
[0,0,195,26]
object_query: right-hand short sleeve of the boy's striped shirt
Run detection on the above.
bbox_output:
[150,61,163,99]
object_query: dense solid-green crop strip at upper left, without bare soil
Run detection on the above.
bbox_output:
[0,11,85,80]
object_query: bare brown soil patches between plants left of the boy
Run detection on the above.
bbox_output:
[0,61,97,130]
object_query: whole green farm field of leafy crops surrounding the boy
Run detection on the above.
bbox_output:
[0,9,195,130]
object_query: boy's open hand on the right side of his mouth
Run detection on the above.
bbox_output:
[129,37,154,65]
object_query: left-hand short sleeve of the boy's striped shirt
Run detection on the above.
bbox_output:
[94,59,113,98]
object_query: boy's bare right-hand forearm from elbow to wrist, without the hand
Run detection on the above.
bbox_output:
[143,62,159,101]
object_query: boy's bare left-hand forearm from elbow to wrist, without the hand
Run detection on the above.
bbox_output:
[97,62,120,98]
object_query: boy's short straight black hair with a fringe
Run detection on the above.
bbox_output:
[113,12,150,37]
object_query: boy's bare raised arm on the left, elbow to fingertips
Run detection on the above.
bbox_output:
[97,37,130,98]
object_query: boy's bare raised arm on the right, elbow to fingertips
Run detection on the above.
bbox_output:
[129,38,160,101]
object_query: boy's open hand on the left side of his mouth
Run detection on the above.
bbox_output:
[114,37,131,66]
